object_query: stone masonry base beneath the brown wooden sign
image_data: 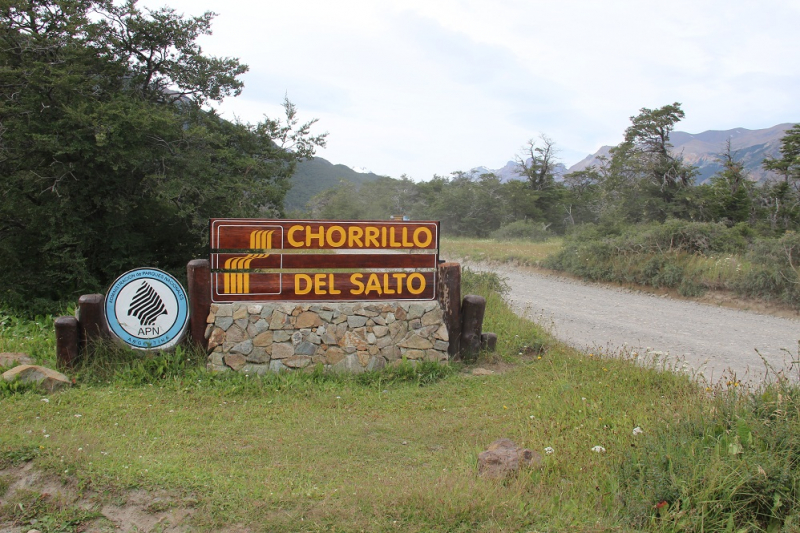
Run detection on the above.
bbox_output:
[205,300,450,374]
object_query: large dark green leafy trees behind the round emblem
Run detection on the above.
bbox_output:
[0,0,324,309]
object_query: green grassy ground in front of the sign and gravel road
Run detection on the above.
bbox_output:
[0,273,800,533]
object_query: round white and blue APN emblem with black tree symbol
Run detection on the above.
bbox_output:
[104,268,189,350]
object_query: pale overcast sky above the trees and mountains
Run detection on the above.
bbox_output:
[140,0,800,180]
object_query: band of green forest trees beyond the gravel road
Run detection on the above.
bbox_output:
[307,103,800,239]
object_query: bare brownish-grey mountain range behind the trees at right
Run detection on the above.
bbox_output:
[567,123,794,183]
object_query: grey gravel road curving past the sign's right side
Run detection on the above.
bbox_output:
[470,265,800,382]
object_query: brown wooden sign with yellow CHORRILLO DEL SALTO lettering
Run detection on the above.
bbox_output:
[211,218,439,302]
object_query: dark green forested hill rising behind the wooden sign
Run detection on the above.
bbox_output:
[284,157,380,213]
